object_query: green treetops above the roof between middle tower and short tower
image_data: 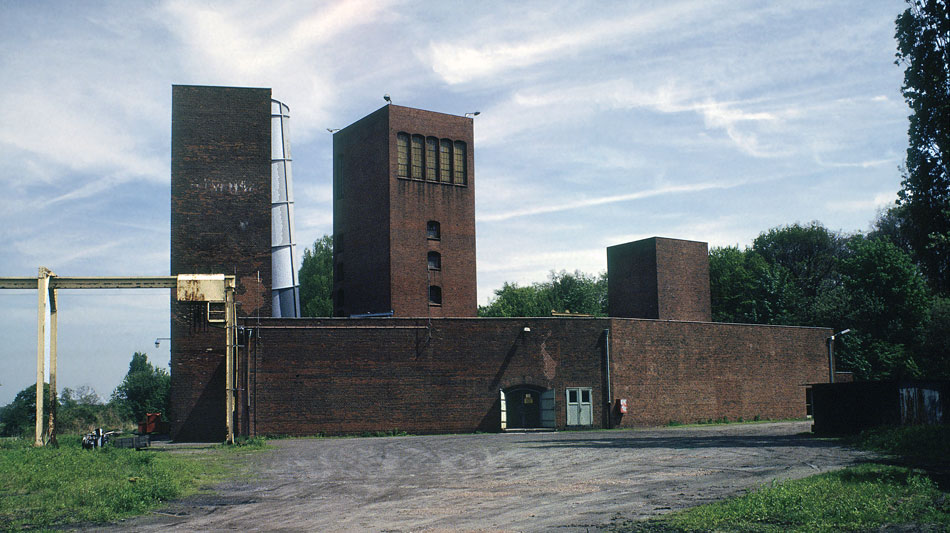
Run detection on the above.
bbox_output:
[478,270,607,317]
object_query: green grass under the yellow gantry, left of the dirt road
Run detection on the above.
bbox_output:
[0,436,253,530]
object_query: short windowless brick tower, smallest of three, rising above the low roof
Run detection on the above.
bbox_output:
[607,237,712,322]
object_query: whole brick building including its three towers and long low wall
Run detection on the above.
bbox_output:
[172,86,831,440]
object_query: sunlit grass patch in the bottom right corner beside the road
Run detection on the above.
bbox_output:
[615,464,950,532]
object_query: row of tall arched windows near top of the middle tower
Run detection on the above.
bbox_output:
[396,132,468,185]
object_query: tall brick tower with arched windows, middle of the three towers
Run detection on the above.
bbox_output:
[333,105,477,317]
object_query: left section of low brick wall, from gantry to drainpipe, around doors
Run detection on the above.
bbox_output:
[248,319,603,435]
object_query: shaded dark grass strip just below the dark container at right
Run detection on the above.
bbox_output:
[848,425,950,464]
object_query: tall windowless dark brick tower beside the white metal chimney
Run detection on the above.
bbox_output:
[171,85,271,440]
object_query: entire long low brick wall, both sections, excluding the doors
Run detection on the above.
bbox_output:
[232,318,830,435]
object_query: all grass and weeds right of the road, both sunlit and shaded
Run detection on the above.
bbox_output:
[612,425,950,532]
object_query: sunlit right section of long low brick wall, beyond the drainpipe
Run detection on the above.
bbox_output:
[610,319,831,426]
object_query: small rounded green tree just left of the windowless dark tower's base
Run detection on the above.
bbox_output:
[112,352,171,421]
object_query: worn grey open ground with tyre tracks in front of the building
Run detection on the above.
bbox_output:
[106,422,867,532]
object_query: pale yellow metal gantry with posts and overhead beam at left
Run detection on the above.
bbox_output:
[0,267,237,446]
